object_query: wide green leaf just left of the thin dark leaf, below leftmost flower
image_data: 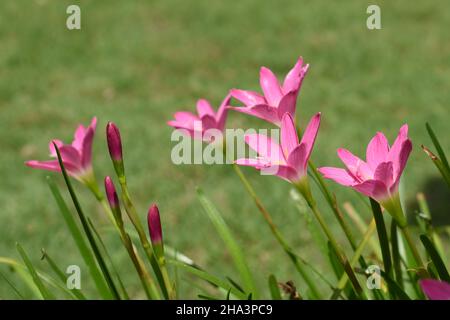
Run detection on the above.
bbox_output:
[47,176,111,299]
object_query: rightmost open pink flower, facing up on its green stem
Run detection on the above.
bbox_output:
[319,124,412,203]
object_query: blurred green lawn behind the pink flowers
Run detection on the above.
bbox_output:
[0,0,450,298]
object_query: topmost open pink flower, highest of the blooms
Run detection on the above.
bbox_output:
[230,57,309,126]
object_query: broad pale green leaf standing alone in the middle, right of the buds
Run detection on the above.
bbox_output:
[197,189,257,296]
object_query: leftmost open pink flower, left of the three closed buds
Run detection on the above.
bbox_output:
[25,117,97,183]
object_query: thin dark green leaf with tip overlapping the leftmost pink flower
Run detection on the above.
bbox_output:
[53,143,120,299]
